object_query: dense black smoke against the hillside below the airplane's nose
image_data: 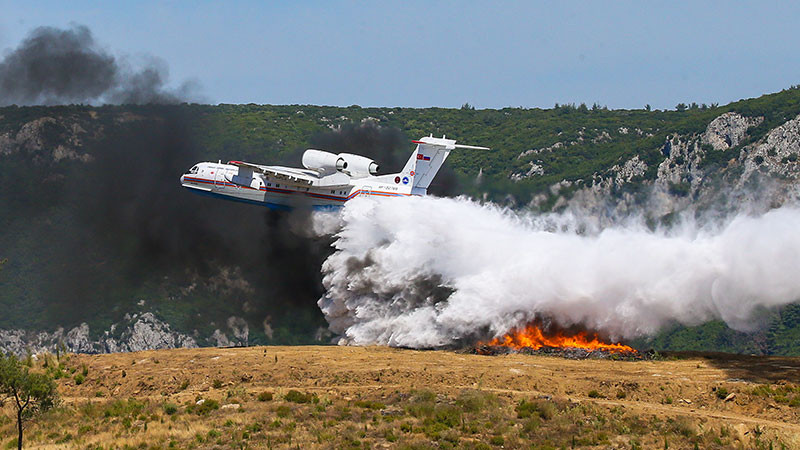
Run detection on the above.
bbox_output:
[16,106,329,334]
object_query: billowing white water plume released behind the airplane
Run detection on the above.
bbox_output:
[318,197,800,347]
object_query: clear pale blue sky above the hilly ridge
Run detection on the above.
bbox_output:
[0,0,800,108]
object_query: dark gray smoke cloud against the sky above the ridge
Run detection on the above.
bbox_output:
[0,25,193,105]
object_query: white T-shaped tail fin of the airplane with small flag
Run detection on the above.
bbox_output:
[403,135,489,195]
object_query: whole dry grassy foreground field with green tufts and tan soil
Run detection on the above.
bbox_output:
[0,346,800,449]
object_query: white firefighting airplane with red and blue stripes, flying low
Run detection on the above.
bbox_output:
[181,135,489,209]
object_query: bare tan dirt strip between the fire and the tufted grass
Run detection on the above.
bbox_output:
[6,346,800,448]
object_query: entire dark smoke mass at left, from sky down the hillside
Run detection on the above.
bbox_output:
[0,26,329,342]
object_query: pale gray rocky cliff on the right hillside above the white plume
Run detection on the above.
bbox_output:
[538,112,800,218]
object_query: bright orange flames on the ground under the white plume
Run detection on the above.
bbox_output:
[479,323,636,353]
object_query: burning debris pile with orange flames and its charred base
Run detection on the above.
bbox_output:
[474,321,645,359]
